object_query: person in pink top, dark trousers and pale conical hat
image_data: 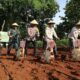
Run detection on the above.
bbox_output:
[25,20,39,56]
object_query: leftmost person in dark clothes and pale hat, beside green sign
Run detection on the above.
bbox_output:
[7,23,20,58]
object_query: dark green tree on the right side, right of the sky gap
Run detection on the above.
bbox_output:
[58,0,80,36]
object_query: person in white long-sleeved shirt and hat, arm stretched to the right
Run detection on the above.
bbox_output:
[45,20,59,57]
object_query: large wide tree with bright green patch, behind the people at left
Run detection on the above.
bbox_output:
[0,0,59,37]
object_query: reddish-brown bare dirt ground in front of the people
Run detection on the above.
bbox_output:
[0,48,80,80]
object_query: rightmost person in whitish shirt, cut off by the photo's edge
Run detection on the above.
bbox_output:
[68,21,80,50]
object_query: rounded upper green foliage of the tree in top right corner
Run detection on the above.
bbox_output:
[65,0,80,24]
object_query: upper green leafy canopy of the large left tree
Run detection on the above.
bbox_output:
[0,0,58,22]
